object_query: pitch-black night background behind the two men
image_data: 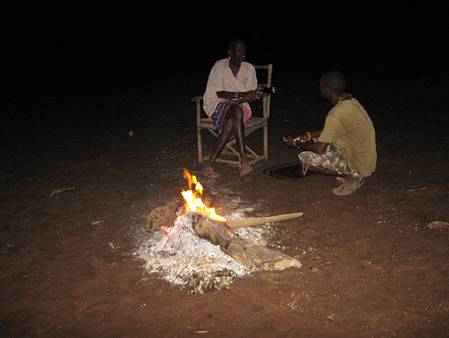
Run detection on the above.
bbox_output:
[1,1,448,136]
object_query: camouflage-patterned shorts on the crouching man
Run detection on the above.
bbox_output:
[298,144,360,177]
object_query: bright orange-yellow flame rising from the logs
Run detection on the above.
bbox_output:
[181,169,226,222]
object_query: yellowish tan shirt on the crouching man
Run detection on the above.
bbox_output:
[318,99,377,177]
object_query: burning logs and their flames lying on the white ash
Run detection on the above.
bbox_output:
[145,171,302,278]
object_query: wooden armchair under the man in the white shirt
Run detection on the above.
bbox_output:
[192,64,273,166]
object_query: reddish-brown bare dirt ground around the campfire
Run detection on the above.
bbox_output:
[0,72,449,337]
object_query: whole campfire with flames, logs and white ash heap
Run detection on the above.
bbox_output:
[140,170,302,292]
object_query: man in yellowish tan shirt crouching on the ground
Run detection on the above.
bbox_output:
[284,71,377,196]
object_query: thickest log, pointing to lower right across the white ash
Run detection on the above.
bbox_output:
[193,217,301,271]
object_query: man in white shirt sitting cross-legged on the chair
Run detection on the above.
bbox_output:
[203,39,263,176]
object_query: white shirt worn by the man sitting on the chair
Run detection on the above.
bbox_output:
[203,58,257,116]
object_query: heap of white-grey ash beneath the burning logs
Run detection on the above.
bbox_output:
[135,211,271,293]
